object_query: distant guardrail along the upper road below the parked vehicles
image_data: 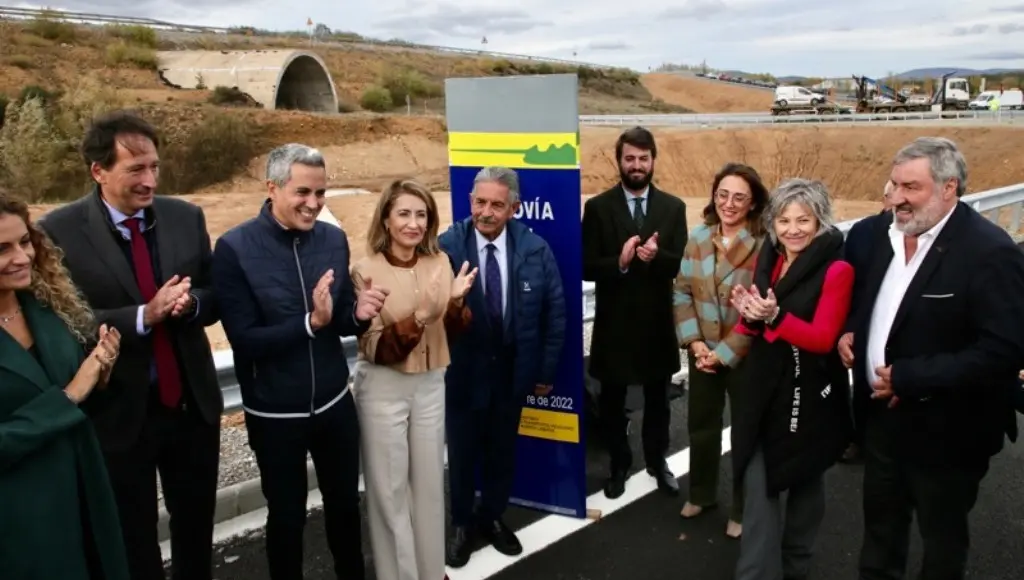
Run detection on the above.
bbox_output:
[580,111,1024,127]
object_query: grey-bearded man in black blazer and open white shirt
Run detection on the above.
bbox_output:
[853,137,1024,580]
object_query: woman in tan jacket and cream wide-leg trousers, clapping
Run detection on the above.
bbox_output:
[352,179,476,580]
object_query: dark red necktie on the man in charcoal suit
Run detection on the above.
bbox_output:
[124,217,181,409]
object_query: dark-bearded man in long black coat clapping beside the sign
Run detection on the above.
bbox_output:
[583,127,687,498]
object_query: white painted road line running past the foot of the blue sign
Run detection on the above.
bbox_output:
[446,426,732,580]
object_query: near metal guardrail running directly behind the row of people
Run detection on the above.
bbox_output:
[213,183,1024,414]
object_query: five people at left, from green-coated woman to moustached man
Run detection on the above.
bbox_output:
[0,112,565,580]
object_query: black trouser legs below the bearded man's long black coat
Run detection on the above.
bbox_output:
[597,377,672,471]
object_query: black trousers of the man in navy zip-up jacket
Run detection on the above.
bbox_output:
[246,393,366,580]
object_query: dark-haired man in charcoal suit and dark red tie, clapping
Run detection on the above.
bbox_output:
[40,112,223,580]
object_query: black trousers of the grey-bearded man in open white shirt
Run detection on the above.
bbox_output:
[860,412,988,580]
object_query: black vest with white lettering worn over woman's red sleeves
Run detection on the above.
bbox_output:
[732,230,852,494]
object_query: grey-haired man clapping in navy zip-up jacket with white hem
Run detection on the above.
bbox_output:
[213,143,387,580]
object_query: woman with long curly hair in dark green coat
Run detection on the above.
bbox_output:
[0,192,128,580]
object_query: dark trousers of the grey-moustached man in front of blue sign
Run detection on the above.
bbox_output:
[445,385,522,526]
